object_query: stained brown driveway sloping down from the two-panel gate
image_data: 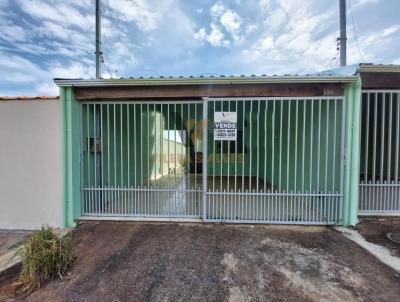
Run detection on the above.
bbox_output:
[3,223,400,302]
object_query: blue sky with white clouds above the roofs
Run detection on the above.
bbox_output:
[0,0,400,95]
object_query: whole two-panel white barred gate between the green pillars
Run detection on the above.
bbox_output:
[81,97,345,224]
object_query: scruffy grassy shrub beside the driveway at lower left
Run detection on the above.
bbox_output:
[19,226,74,294]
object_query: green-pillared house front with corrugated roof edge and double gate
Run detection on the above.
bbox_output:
[55,75,361,226]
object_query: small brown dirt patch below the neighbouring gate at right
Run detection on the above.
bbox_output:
[357,218,400,257]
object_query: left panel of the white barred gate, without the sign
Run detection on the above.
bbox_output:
[81,101,203,219]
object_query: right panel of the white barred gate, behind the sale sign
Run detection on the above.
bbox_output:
[205,97,345,224]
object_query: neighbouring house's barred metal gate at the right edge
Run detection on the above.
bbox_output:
[359,90,400,215]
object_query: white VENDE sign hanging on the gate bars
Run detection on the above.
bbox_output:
[214,112,237,141]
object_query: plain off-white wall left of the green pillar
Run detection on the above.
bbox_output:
[0,98,62,229]
